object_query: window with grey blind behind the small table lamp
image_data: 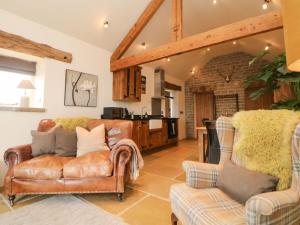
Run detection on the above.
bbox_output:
[0,55,36,106]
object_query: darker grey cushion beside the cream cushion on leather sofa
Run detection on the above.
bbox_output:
[54,127,77,156]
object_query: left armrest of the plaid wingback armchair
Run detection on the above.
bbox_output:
[182,161,222,188]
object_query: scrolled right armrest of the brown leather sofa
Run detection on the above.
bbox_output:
[110,145,131,176]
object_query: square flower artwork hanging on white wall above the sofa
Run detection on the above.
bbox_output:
[65,70,98,107]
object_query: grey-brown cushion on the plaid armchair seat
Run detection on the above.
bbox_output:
[217,160,278,204]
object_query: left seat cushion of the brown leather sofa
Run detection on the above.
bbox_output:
[14,155,72,180]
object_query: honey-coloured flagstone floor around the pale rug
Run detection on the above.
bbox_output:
[0,140,198,225]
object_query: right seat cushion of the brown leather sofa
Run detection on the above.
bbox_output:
[63,151,113,179]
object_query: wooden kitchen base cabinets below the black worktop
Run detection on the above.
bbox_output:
[132,118,178,151]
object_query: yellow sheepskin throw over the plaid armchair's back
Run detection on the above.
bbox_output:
[233,110,300,190]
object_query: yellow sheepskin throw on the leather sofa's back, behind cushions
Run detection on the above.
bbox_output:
[54,117,91,131]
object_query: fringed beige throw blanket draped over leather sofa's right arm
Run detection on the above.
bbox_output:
[114,139,144,180]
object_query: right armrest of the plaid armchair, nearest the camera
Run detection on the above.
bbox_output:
[246,189,299,219]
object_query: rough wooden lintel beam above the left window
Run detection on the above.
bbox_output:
[0,30,72,63]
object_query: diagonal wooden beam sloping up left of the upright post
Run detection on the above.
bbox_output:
[110,0,164,62]
